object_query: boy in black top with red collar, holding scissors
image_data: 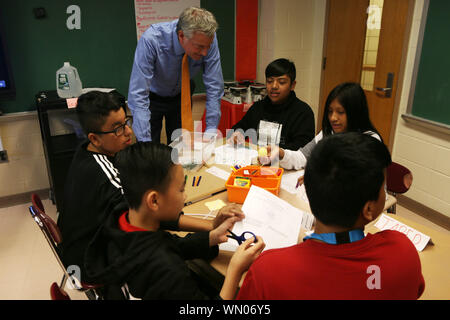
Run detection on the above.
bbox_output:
[85,142,265,299]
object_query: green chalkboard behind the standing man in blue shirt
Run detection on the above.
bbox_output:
[0,0,235,113]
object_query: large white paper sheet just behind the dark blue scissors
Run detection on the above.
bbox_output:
[219,185,312,251]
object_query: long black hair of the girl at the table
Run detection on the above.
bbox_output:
[322,82,381,138]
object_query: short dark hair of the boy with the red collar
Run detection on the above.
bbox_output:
[115,142,178,209]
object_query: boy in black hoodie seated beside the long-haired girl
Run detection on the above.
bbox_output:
[228,59,315,150]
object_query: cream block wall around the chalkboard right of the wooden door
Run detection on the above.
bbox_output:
[392,0,450,217]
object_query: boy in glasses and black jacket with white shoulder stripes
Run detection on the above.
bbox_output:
[58,91,243,282]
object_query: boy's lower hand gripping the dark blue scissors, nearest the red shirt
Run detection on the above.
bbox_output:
[228,236,266,275]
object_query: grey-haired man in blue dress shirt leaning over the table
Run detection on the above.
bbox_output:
[128,7,223,142]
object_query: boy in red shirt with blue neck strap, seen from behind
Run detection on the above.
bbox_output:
[237,133,425,299]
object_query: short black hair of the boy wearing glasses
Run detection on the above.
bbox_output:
[76,91,126,135]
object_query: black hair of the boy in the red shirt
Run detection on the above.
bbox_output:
[304,132,391,228]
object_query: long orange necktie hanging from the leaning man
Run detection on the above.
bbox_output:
[181,54,194,132]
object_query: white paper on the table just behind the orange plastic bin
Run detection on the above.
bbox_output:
[214,144,258,167]
